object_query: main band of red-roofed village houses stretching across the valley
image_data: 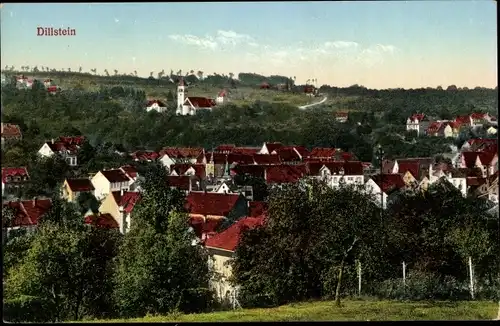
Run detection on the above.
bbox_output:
[2,137,498,299]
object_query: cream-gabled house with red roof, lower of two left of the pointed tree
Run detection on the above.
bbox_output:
[99,190,141,233]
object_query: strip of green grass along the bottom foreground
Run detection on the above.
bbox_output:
[82,300,498,323]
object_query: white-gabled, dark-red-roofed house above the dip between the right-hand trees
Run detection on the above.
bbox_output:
[365,174,406,209]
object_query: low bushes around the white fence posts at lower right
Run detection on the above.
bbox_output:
[375,271,470,301]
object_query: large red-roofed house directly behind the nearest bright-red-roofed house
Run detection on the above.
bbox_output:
[185,191,248,240]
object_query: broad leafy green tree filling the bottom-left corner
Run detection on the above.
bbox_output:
[5,202,119,321]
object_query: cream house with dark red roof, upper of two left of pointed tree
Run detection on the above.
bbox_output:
[91,166,138,200]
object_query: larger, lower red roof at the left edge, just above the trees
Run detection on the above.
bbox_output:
[2,199,52,227]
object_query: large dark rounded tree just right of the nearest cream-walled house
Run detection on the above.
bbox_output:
[233,182,380,305]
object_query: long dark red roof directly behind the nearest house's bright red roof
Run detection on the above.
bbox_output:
[186,192,240,216]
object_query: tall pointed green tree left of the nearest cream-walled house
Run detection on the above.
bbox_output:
[114,166,210,316]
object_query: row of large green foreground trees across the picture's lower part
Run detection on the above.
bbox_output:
[2,166,500,322]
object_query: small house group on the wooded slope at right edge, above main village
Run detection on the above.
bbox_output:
[406,113,498,138]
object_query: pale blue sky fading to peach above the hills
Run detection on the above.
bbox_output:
[0,0,498,89]
